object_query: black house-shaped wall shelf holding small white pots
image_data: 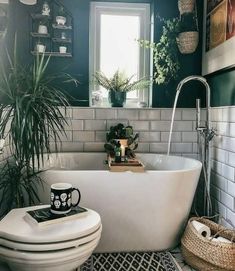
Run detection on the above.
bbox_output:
[29,0,73,57]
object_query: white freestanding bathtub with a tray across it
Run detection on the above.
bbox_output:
[39,153,201,252]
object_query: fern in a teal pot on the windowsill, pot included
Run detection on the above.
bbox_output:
[94,70,150,107]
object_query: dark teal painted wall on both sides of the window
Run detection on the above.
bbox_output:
[6,0,207,107]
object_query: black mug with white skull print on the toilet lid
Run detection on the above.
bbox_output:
[51,183,81,215]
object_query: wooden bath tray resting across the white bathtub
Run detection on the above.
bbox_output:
[108,158,144,172]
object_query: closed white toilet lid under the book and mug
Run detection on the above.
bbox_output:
[0,205,101,244]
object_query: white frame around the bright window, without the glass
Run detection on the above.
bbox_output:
[89,2,151,106]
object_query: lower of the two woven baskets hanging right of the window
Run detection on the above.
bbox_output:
[176,31,199,54]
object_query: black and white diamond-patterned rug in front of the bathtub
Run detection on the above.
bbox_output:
[81,252,181,271]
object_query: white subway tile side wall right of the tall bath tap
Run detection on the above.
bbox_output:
[211,107,235,228]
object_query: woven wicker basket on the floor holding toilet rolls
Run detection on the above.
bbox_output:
[181,217,235,271]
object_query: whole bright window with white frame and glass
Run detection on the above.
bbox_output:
[89,2,150,107]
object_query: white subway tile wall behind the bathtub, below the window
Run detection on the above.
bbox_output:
[53,107,198,156]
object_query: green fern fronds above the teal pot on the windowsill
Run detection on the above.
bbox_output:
[94,70,150,92]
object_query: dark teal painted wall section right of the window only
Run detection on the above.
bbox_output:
[153,0,205,107]
